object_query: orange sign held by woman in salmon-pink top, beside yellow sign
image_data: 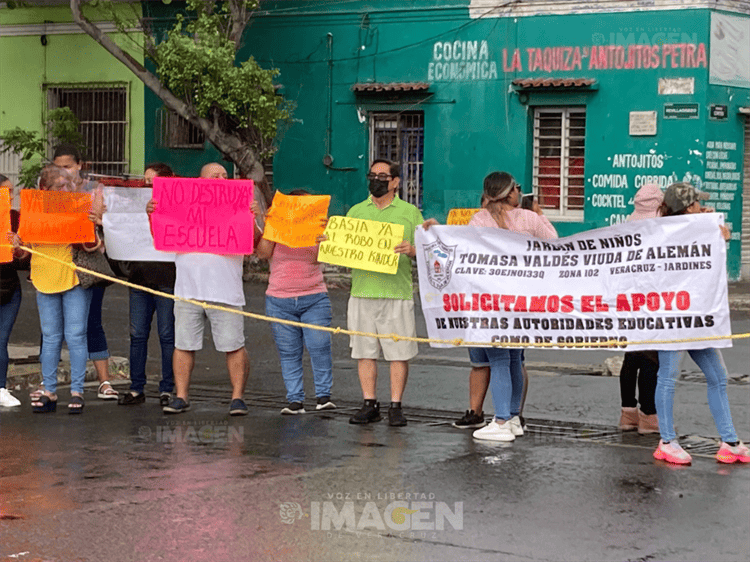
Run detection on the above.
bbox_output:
[263,191,331,248]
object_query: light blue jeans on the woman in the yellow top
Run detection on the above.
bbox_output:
[36,285,91,393]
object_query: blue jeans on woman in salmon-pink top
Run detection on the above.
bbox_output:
[266,293,333,402]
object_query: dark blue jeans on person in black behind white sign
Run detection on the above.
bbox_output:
[130,287,174,394]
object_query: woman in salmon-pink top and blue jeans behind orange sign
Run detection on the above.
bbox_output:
[255,189,336,415]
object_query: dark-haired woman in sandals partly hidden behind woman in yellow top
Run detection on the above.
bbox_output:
[52,144,118,400]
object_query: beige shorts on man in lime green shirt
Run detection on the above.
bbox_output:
[347,297,417,361]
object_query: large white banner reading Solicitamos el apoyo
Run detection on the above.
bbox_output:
[416,213,732,351]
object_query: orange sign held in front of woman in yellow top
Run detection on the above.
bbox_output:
[18,189,96,244]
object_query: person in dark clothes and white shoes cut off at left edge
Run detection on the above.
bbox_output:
[0,174,23,407]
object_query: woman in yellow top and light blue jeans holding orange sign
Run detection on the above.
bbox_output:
[15,165,101,414]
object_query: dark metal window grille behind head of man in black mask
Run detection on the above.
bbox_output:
[370,111,424,209]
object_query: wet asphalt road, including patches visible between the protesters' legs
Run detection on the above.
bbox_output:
[0,285,750,562]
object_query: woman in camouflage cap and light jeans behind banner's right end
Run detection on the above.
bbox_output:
[654,183,750,464]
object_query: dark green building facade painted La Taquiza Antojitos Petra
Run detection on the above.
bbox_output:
[146,0,750,279]
